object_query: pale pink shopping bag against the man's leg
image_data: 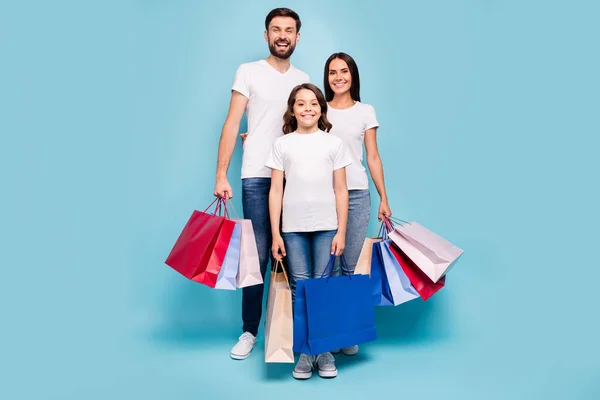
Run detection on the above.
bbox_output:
[233,218,263,288]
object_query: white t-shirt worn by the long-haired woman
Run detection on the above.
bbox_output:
[327,101,379,190]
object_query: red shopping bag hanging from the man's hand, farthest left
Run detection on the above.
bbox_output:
[165,199,235,288]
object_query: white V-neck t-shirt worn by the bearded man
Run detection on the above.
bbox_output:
[232,60,310,179]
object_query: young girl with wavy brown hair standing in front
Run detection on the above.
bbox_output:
[266,83,351,379]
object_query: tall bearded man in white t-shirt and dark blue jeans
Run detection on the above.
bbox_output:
[214,8,310,360]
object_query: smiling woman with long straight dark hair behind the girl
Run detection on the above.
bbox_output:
[323,53,392,355]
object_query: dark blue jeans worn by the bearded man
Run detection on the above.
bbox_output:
[242,178,273,336]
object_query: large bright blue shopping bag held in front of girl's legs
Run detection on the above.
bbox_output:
[294,255,377,355]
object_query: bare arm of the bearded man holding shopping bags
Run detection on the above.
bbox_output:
[214,90,248,198]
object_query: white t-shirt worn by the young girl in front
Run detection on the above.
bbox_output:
[266,130,352,232]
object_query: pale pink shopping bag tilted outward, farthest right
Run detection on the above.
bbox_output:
[388,221,463,282]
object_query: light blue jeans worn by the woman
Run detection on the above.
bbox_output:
[336,190,371,275]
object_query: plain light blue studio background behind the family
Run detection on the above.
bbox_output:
[0,0,600,400]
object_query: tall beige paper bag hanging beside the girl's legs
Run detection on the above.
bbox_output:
[265,261,294,363]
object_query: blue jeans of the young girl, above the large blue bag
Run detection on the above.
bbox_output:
[282,230,337,304]
